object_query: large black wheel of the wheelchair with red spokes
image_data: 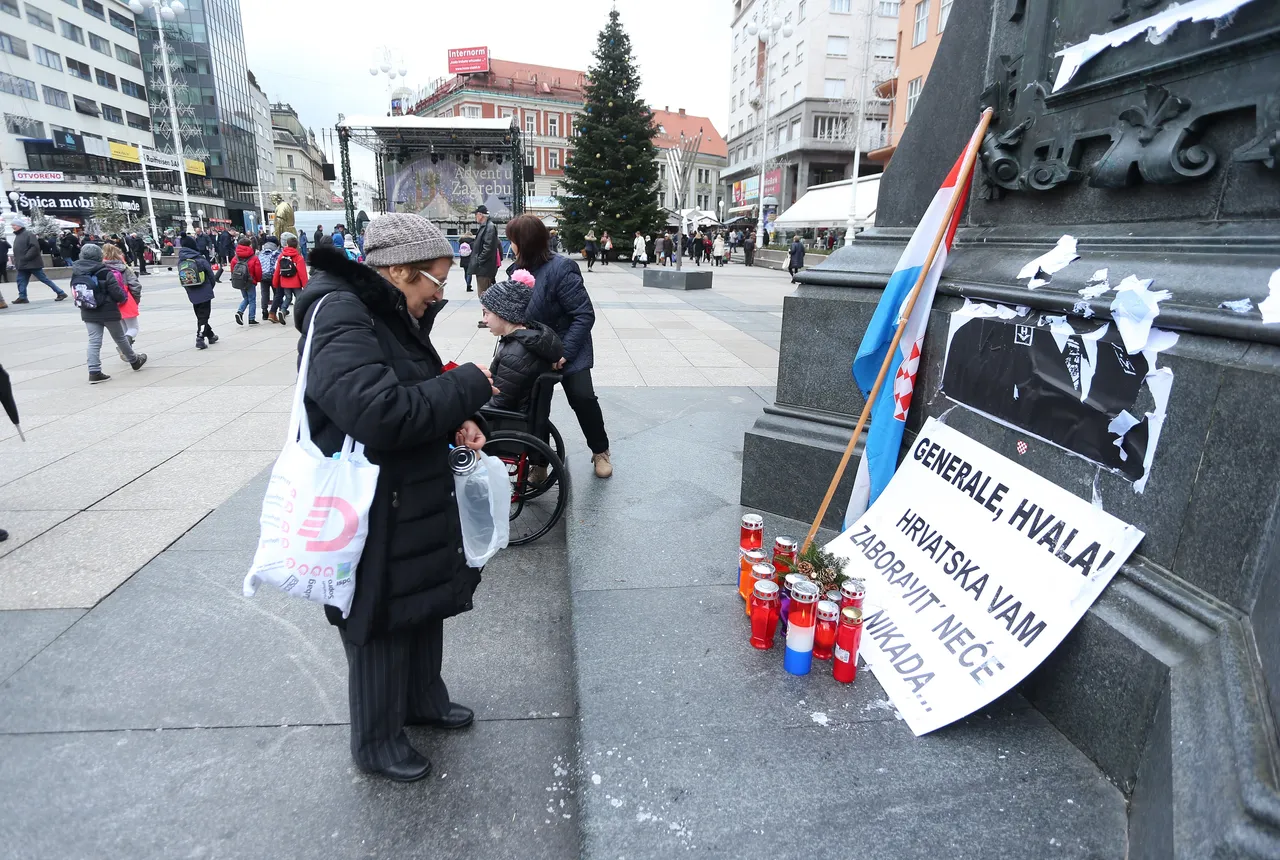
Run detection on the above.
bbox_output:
[484,430,568,546]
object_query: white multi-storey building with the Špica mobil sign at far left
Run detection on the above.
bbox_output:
[0,0,218,229]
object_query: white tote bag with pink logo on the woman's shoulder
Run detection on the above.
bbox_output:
[244,296,378,618]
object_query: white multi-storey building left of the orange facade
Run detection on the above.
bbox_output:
[723,0,901,218]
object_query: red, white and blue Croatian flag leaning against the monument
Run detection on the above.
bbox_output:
[845,139,978,529]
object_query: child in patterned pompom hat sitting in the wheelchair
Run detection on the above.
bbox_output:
[480,269,564,414]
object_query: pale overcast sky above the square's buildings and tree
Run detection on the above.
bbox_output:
[241,0,731,180]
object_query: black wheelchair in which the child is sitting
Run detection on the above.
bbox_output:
[480,374,570,546]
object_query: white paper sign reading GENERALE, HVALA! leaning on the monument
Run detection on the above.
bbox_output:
[827,418,1143,735]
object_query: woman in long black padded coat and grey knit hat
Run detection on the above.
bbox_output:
[294,214,497,782]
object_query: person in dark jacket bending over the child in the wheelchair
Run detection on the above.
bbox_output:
[507,215,613,477]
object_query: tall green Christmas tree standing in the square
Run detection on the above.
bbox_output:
[559,9,666,259]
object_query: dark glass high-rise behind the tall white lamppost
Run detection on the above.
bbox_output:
[134,0,259,229]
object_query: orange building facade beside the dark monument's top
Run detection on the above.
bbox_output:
[868,0,954,165]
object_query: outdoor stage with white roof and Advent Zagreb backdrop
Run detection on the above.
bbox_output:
[337,115,527,233]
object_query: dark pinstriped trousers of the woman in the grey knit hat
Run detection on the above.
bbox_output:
[339,618,449,770]
